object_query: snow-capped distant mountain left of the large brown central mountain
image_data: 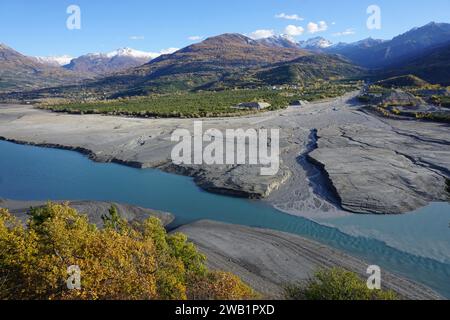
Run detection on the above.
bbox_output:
[64,48,158,76]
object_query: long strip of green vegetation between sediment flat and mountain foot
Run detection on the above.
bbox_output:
[41,84,355,118]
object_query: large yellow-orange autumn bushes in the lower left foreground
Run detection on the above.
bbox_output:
[0,203,256,300]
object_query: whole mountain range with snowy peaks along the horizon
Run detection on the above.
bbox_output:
[0,22,450,96]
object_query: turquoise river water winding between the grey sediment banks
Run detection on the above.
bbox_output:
[0,141,450,298]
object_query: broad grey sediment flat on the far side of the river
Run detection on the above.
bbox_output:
[0,92,450,218]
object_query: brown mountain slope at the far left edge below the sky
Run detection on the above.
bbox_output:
[0,44,84,92]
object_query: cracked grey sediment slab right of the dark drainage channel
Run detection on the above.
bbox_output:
[309,125,450,214]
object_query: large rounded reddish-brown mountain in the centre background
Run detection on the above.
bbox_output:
[0,34,362,98]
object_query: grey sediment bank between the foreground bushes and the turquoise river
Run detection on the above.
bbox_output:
[175,221,441,300]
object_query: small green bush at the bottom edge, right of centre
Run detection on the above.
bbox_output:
[286,268,397,300]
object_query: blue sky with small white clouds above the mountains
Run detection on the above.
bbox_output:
[0,0,450,57]
